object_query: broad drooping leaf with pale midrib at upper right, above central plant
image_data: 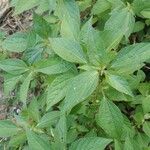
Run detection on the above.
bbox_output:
[105,7,135,38]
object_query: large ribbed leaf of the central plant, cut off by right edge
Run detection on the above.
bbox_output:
[111,43,150,73]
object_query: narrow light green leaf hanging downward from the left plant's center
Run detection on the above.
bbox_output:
[20,73,33,104]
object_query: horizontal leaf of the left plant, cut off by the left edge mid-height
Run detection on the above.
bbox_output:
[0,59,28,75]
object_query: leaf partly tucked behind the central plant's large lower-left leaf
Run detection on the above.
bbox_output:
[46,74,73,110]
